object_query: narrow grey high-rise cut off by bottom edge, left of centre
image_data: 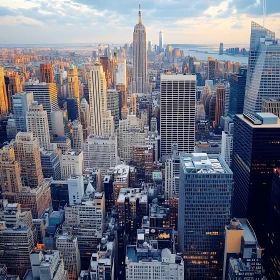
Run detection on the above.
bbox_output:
[56,232,81,280]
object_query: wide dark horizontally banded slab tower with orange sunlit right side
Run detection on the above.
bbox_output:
[25,82,59,132]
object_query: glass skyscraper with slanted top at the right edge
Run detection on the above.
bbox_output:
[244,22,280,114]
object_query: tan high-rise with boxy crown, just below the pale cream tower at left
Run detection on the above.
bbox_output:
[14,132,44,188]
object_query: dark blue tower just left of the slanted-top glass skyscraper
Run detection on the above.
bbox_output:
[228,69,247,118]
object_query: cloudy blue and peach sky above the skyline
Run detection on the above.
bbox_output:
[0,0,280,44]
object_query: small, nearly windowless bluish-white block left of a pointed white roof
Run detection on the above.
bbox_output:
[67,175,84,206]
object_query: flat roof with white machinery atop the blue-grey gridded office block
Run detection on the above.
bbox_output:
[180,153,232,174]
